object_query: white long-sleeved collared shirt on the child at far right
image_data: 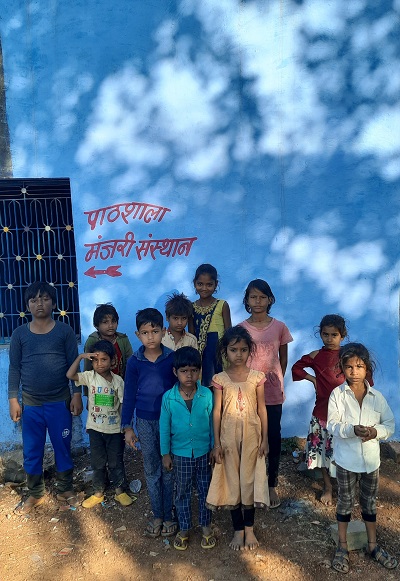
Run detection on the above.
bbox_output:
[327,381,394,474]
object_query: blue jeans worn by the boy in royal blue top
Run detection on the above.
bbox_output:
[136,418,174,522]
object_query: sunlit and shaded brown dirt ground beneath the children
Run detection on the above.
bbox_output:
[0,442,400,581]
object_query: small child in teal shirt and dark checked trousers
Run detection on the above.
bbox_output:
[160,347,216,551]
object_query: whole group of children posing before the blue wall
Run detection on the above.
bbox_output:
[9,264,397,573]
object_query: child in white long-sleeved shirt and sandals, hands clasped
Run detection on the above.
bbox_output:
[327,343,397,573]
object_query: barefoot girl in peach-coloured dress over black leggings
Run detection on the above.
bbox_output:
[207,326,269,551]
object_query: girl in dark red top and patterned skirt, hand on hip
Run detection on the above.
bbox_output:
[292,315,347,506]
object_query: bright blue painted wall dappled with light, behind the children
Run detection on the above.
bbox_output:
[0,0,400,441]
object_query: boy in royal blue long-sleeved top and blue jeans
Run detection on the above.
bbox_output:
[121,308,177,538]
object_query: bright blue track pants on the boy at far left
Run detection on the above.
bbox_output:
[22,401,73,496]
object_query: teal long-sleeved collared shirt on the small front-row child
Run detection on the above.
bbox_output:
[160,381,213,458]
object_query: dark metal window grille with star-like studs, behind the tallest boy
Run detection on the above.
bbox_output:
[0,178,80,343]
